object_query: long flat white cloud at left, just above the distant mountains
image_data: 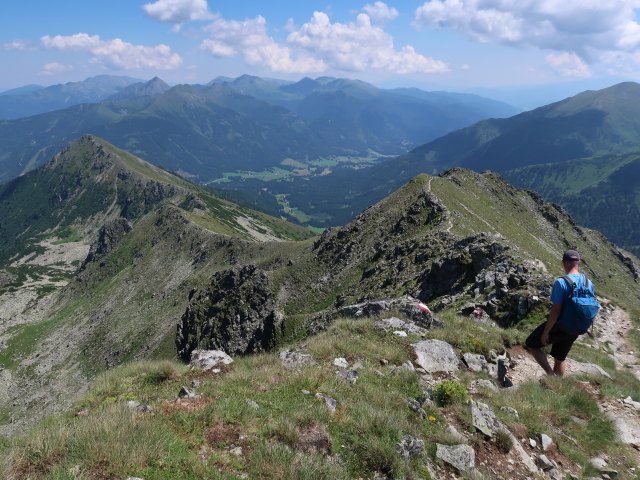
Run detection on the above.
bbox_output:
[40,33,182,70]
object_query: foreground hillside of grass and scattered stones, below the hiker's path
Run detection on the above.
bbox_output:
[0,315,640,480]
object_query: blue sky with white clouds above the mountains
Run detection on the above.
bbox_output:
[0,0,640,105]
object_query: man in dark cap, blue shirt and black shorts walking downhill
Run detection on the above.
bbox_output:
[525,250,598,377]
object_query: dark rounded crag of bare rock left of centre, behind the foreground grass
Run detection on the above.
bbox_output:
[176,265,283,360]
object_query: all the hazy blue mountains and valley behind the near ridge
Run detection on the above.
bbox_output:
[0,75,640,253]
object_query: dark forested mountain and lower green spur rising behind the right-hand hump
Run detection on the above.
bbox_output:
[274,82,640,254]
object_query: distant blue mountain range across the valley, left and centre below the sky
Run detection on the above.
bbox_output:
[0,76,514,182]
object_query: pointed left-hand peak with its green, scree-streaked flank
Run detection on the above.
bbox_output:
[0,135,311,431]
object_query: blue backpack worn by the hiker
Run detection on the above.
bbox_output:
[558,275,600,334]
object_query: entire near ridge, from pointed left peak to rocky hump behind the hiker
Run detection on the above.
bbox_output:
[0,136,640,433]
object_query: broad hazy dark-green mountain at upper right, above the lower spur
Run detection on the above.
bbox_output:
[404,82,640,172]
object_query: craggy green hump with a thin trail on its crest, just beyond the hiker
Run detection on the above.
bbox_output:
[178,169,639,358]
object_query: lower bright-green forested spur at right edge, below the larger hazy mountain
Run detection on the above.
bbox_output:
[504,153,640,256]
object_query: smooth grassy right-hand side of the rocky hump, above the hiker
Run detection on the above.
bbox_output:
[431,170,638,305]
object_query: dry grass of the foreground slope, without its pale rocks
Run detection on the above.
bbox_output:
[0,316,640,480]
